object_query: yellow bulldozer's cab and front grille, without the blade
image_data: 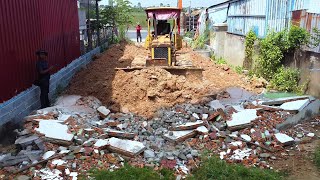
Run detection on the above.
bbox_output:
[145,7,182,66]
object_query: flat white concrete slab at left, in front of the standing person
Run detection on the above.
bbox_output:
[35,120,73,142]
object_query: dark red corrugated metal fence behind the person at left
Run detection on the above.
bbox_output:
[0,0,80,103]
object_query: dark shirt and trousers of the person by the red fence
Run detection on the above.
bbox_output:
[37,60,50,108]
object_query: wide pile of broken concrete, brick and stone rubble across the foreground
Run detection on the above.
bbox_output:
[0,88,320,179]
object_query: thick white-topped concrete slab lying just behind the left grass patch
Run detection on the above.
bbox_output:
[108,137,146,157]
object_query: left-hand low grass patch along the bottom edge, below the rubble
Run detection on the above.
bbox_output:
[91,164,175,180]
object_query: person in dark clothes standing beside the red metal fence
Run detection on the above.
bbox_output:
[36,50,54,108]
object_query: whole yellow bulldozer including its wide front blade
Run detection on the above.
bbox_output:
[117,7,203,78]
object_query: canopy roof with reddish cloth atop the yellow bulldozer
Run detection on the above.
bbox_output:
[146,7,181,20]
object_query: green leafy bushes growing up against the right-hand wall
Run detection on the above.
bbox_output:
[251,25,310,92]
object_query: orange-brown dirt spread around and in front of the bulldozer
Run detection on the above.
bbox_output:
[66,42,261,118]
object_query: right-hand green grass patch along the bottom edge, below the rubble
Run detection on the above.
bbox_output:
[188,157,284,180]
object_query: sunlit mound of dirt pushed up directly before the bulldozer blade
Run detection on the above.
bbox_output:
[112,68,205,116]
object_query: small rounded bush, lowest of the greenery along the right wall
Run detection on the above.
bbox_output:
[270,67,300,92]
